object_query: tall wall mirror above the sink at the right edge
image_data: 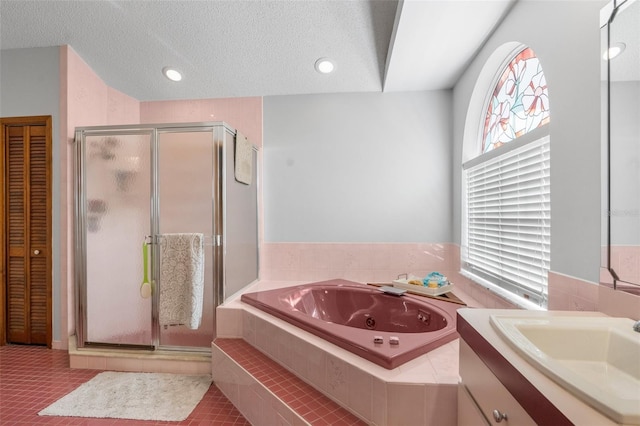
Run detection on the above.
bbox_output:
[601,0,640,294]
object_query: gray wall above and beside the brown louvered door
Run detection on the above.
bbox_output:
[0,47,62,341]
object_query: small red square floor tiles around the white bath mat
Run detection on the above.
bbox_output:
[0,345,249,426]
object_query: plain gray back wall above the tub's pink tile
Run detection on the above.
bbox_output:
[264,91,452,242]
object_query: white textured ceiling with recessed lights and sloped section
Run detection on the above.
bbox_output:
[0,0,514,101]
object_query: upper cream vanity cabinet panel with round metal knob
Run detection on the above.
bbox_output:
[460,339,536,426]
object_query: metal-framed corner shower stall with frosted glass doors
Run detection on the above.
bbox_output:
[74,122,259,351]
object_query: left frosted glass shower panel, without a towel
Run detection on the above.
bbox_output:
[84,134,151,345]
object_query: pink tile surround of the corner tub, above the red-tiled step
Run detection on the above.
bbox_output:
[218,281,460,425]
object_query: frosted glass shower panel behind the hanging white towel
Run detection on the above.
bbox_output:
[158,130,215,348]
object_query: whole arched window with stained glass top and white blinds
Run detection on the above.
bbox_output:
[460,42,551,309]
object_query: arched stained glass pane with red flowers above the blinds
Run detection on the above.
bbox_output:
[482,47,549,153]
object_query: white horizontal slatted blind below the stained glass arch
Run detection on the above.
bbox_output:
[462,136,551,306]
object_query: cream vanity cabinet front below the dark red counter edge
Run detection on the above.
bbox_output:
[458,339,536,426]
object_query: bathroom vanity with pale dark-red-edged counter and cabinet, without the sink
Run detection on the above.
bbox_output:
[457,308,632,426]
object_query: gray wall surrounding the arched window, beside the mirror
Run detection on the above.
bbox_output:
[453,0,606,282]
